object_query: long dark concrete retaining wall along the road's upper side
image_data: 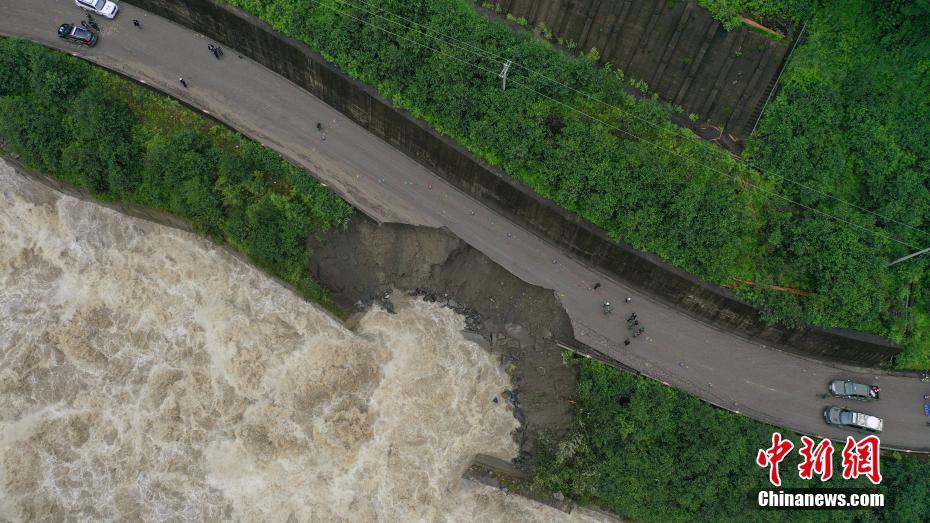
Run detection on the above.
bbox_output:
[123,0,900,366]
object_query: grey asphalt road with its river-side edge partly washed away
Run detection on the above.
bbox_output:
[0,0,930,452]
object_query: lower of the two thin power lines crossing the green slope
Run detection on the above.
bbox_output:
[310,0,918,249]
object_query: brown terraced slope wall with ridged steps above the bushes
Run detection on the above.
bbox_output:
[492,0,791,143]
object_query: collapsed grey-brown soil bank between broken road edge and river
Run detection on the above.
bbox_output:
[310,215,576,470]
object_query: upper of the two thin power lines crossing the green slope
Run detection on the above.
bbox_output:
[324,0,930,242]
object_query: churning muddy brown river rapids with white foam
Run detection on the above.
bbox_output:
[0,163,600,522]
